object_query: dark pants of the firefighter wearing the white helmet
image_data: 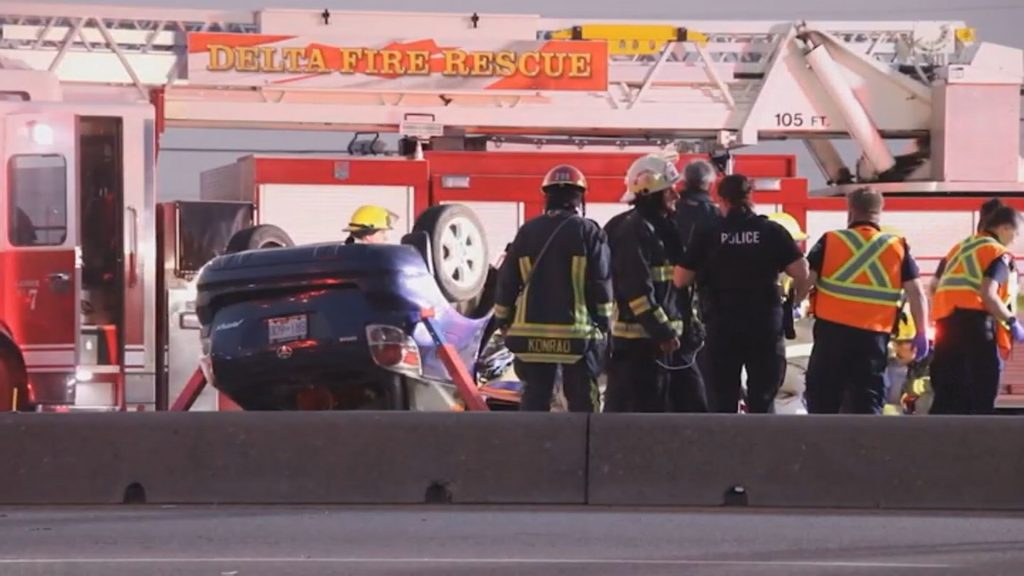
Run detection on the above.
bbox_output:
[604,338,708,412]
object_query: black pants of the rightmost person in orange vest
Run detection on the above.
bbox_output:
[929,311,1002,414]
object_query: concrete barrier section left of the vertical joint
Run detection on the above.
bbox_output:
[0,412,587,504]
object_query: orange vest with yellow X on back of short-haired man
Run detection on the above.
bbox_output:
[813,225,906,333]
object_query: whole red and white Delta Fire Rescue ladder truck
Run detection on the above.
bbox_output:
[0,3,1024,410]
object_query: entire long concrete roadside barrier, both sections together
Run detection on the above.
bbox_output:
[0,412,1024,510]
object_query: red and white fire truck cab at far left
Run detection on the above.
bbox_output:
[0,70,156,409]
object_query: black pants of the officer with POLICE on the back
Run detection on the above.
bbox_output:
[708,306,785,414]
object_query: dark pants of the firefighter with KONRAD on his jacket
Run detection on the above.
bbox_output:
[513,341,605,412]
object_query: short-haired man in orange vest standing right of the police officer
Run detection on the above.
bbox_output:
[806,188,928,414]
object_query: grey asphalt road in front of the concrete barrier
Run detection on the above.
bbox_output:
[0,506,1024,576]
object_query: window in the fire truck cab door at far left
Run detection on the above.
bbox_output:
[7,154,68,247]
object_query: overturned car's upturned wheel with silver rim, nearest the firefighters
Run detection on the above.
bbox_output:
[413,204,490,302]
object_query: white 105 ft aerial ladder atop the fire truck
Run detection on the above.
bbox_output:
[0,3,1024,181]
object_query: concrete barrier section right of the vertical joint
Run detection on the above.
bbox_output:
[588,414,1024,510]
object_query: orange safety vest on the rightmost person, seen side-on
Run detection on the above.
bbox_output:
[932,234,1016,356]
